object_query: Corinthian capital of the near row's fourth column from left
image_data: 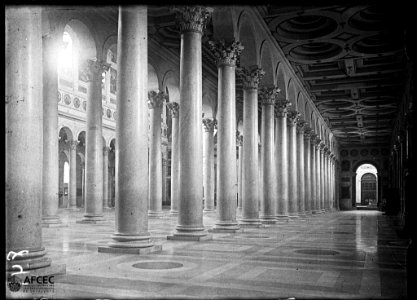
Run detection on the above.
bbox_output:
[208,40,244,67]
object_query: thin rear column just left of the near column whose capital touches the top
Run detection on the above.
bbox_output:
[167,102,180,215]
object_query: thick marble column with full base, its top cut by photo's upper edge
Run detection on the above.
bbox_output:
[98,6,162,254]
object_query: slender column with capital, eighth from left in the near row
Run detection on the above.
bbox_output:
[287,110,300,218]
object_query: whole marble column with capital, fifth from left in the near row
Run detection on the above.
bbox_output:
[239,66,265,227]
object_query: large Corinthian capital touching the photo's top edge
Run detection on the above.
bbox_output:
[172,6,213,33]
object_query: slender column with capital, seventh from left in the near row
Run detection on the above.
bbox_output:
[275,99,291,220]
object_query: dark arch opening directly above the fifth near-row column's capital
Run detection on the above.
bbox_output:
[238,10,259,67]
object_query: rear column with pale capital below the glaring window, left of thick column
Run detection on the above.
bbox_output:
[77,60,108,224]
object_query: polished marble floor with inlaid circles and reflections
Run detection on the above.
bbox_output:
[8,208,408,299]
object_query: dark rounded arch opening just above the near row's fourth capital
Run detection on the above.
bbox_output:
[211,6,238,42]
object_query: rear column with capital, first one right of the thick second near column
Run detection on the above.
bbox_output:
[148,91,167,217]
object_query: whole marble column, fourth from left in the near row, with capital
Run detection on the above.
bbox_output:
[210,41,243,232]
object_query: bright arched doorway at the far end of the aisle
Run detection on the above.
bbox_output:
[355,164,378,209]
